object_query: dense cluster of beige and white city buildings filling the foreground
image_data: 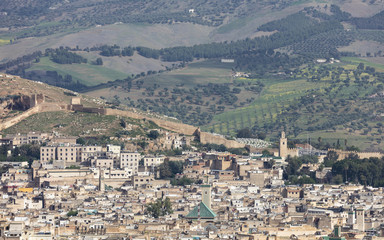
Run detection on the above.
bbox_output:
[0,132,384,240]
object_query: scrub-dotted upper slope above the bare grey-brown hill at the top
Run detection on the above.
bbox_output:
[0,0,296,39]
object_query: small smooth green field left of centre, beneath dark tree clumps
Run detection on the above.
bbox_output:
[28,57,127,86]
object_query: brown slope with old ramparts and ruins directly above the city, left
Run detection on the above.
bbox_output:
[0,74,245,148]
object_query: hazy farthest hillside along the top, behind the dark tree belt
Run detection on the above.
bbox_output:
[0,0,384,62]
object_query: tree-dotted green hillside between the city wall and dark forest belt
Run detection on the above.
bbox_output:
[83,58,384,150]
